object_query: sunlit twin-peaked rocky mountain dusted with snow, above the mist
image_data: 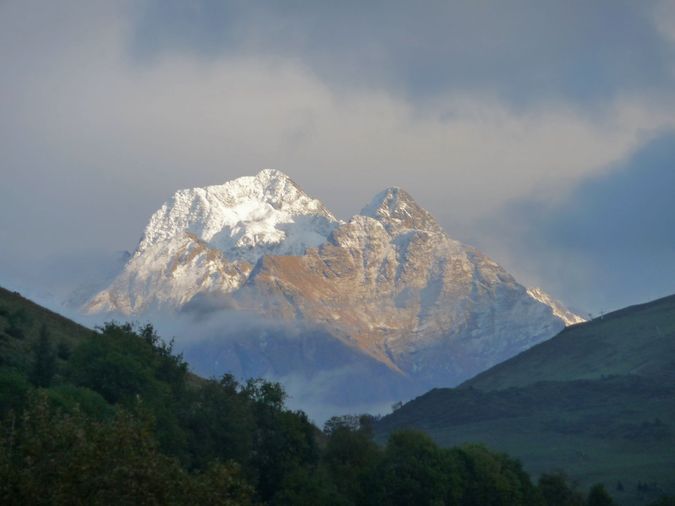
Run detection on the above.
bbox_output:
[85,170,582,412]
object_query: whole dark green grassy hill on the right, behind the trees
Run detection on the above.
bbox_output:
[377,296,675,504]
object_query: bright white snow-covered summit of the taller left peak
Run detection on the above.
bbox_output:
[136,169,339,263]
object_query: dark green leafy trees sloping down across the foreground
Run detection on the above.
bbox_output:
[0,323,673,506]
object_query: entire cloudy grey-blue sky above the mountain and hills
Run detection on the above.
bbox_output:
[0,0,675,314]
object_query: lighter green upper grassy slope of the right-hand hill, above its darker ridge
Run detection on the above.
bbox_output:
[461,296,675,390]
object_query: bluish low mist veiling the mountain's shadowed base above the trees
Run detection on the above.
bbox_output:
[80,296,418,424]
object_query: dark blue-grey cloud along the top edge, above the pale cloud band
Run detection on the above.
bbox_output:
[133,0,673,103]
